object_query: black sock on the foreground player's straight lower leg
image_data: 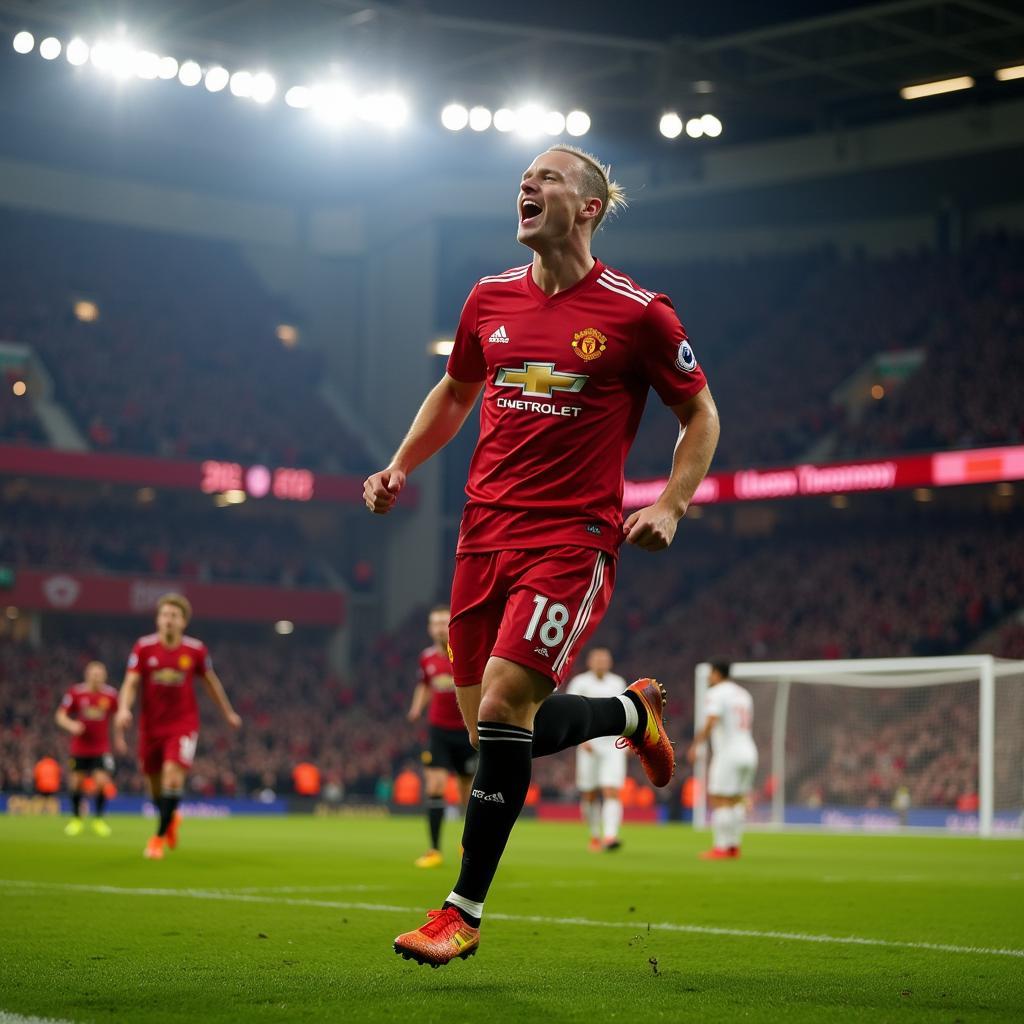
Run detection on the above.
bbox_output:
[444,722,532,928]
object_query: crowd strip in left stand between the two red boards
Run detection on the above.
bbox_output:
[0,493,332,587]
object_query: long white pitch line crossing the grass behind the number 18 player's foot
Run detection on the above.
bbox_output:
[0,879,1024,958]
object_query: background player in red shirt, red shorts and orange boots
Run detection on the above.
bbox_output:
[114,594,242,860]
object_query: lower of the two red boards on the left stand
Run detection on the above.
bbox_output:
[2,569,345,627]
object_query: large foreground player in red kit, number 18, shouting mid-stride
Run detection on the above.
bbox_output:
[364,145,719,967]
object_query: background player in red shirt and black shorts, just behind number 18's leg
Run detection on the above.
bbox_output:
[409,604,477,867]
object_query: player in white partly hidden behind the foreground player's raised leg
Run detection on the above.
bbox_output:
[565,647,627,851]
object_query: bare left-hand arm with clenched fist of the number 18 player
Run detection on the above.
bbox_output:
[362,374,483,515]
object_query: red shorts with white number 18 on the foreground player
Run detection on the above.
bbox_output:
[449,547,615,686]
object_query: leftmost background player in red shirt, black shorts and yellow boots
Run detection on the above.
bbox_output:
[54,662,118,839]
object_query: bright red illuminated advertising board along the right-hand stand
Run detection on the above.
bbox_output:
[623,445,1024,509]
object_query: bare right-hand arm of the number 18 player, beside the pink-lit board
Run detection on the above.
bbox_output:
[623,387,720,551]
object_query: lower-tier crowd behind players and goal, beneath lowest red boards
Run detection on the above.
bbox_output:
[0,499,1024,807]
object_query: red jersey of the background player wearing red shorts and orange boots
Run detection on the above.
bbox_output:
[128,633,210,739]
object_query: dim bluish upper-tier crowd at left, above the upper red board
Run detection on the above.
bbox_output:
[0,210,369,473]
